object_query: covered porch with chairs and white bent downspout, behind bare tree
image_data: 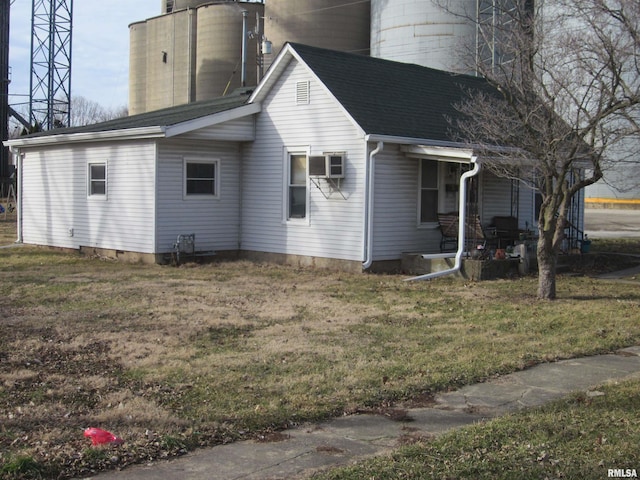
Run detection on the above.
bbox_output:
[401,145,584,280]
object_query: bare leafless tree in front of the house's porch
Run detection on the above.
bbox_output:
[439,0,640,299]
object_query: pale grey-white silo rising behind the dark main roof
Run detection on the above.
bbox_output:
[371,0,478,73]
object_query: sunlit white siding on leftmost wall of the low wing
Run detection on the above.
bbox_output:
[22,141,155,253]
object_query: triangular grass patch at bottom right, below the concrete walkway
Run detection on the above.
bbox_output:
[313,380,640,480]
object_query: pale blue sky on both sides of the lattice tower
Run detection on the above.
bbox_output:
[9,0,161,108]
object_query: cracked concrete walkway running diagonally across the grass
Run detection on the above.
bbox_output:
[84,347,640,480]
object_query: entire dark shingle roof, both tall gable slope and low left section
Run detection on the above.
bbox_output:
[18,43,487,141]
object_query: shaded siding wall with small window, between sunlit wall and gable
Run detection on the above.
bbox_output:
[156,140,241,253]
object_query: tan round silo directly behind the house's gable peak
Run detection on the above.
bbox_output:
[264,0,370,66]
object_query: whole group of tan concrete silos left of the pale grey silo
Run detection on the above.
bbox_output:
[129,0,370,115]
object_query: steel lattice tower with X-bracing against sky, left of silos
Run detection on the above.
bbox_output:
[29,0,73,130]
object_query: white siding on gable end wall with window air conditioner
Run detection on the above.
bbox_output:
[242,61,365,261]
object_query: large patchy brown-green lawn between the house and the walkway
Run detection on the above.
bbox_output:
[0,220,640,478]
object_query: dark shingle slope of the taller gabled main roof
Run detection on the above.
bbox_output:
[291,43,488,141]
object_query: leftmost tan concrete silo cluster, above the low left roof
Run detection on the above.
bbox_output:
[129,0,264,114]
